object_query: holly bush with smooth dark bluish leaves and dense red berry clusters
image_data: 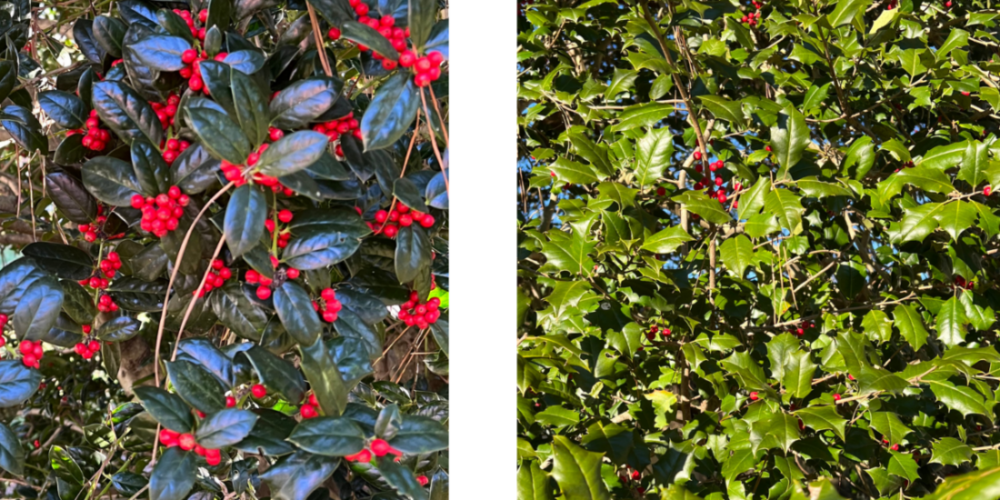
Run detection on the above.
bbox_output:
[0,0,449,500]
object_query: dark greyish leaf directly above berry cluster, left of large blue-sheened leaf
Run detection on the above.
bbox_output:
[269,78,344,130]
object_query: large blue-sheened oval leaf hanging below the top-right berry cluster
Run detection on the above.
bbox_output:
[360,71,420,151]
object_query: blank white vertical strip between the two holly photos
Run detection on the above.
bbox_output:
[448,0,517,500]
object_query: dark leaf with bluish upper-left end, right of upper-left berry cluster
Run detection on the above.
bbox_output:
[92,80,163,144]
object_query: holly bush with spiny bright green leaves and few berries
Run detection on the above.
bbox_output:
[517,0,1000,500]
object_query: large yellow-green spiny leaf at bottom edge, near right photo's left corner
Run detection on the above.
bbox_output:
[552,436,611,500]
